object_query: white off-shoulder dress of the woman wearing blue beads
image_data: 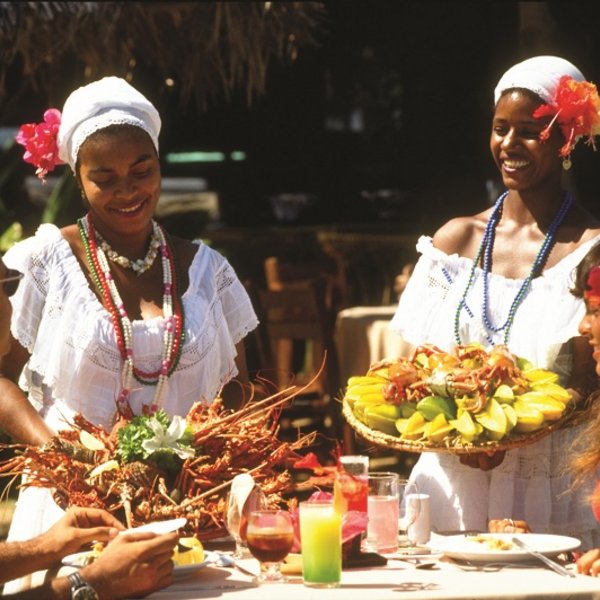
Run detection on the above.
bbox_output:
[390,236,600,548]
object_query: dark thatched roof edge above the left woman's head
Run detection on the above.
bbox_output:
[0,2,325,108]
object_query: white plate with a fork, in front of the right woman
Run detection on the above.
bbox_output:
[429,533,581,562]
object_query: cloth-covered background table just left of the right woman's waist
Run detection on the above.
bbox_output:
[334,304,409,385]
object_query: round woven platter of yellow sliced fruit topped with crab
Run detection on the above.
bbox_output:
[342,343,574,454]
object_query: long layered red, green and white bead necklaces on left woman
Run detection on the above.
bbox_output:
[77,214,184,413]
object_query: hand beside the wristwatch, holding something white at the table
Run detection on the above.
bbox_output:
[80,532,179,600]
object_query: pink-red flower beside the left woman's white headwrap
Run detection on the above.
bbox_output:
[15,108,64,181]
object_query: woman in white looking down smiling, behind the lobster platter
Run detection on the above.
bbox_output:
[0,77,257,592]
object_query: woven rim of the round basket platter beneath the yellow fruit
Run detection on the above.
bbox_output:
[342,400,573,454]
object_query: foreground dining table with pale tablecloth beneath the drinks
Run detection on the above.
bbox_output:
[148,559,600,600]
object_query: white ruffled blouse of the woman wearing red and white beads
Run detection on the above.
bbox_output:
[4,224,258,429]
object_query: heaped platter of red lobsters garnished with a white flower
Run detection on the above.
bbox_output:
[0,386,316,541]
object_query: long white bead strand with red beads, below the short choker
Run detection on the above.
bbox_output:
[83,215,175,412]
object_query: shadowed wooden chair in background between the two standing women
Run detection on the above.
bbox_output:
[257,279,343,454]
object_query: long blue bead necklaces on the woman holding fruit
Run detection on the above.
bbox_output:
[454,192,573,345]
